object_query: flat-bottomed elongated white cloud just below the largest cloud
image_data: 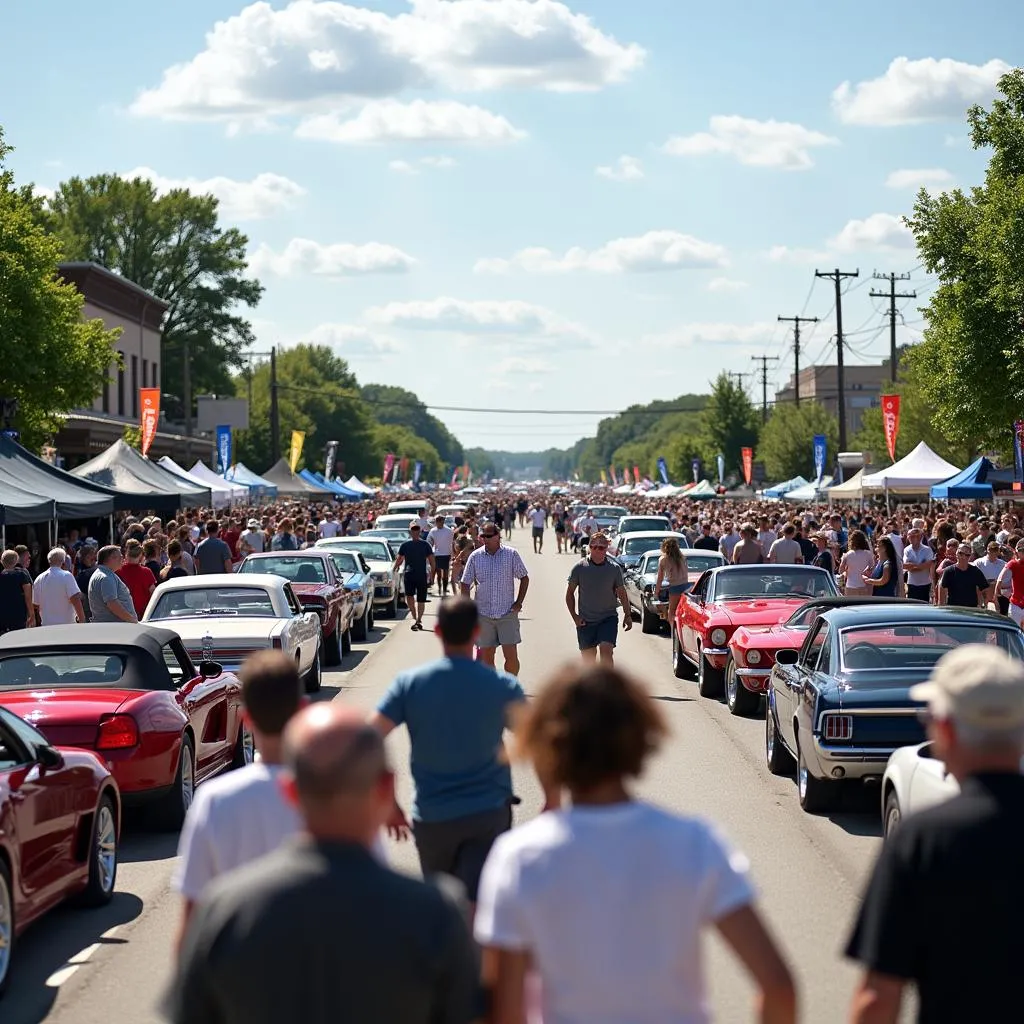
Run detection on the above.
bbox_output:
[295,99,526,143]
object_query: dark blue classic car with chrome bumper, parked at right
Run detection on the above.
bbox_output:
[765,602,1024,812]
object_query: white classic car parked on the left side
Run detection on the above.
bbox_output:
[142,572,324,693]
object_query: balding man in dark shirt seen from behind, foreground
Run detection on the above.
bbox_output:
[164,701,479,1024]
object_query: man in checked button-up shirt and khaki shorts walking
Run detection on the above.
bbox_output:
[461,523,529,676]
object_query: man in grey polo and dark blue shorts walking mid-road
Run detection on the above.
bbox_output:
[565,532,633,665]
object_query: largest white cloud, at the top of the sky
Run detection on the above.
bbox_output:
[125,0,645,124]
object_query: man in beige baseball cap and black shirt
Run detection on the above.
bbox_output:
[846,644,1024,1024]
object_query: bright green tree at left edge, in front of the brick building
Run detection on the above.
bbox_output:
[0,130,121,449]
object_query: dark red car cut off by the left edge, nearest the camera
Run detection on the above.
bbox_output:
[0,707,121,995]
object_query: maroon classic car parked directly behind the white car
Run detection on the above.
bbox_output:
[236,548,355,666]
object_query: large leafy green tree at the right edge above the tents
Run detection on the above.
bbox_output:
[908,70,1024,447]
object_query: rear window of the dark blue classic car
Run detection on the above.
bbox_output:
[840,623,1024,672]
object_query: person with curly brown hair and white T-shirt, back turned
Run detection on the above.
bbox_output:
[475,665,797,1024]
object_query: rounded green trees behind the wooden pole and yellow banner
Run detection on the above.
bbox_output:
[234,345,378,476]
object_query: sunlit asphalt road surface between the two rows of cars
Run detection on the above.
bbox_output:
[6,529,910,1024]
